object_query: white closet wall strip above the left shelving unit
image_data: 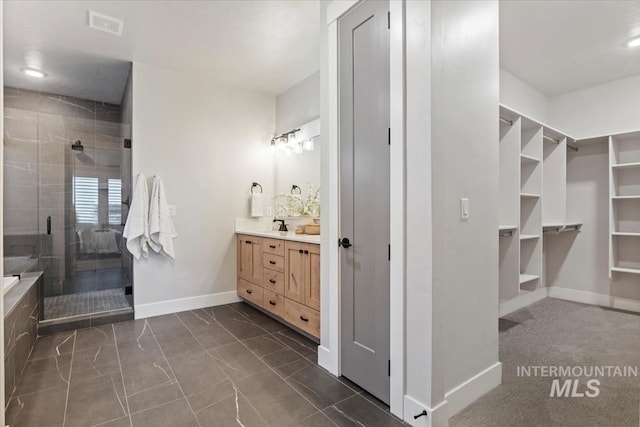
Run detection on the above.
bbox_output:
[500,68,553,126]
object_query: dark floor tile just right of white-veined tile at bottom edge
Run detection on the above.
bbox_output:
[236,371,316,426]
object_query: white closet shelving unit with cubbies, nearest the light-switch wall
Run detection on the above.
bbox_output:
[499,105,584,315]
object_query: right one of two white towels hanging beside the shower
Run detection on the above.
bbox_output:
[149,176,178,261]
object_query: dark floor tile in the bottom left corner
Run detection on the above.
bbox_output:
[6,386,67,427]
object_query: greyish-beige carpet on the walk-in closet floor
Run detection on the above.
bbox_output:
[449,298,640,427]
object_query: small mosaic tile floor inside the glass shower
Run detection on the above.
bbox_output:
[44,288,130,320]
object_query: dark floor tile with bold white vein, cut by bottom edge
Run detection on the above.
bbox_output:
[196,393,267,427]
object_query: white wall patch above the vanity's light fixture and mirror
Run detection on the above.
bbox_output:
[276,71,320,135]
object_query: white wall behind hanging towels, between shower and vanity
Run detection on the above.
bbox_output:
[132,63,275,317]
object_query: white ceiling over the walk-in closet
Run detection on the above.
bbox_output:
[500,0,640,96]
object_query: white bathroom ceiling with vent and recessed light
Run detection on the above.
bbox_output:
[3,0,320,104]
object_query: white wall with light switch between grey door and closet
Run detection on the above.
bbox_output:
[430,1,501,414]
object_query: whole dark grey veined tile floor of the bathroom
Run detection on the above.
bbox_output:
[7,303,403,427]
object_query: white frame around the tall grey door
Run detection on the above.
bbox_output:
[318,0,406,419]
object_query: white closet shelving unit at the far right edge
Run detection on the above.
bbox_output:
[609,132,640,277]
